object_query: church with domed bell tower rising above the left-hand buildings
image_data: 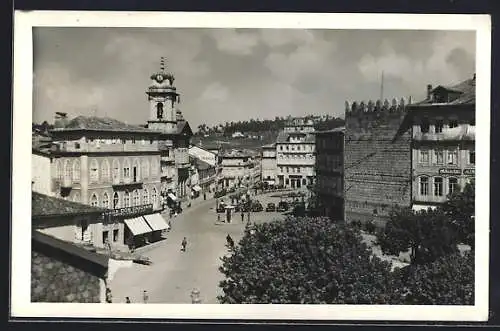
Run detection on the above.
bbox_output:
[146,58,193,200]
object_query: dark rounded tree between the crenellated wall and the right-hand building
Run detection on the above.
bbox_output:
[378,208,457,264]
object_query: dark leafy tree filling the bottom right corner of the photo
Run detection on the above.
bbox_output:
[394,251,474,305]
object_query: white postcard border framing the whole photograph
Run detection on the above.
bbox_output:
[10,11,491,321]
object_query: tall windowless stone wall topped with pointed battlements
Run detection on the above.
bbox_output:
[344,100,411,223]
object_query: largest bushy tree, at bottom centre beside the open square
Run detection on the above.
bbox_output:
[218,218,401,304]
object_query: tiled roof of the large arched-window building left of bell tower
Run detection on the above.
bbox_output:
[52,116,158,134]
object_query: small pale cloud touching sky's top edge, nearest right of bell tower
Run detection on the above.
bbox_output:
[208,29,259,55]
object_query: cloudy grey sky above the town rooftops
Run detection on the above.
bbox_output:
[33,27,476,129]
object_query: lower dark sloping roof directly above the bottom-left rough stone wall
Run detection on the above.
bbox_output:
[31,230,109,268]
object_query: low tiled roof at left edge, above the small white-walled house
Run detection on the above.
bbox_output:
[31,192,106,218]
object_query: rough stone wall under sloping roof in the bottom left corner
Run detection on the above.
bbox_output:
[31,251,104,303]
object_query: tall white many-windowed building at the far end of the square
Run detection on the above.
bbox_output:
[276,118,315,189]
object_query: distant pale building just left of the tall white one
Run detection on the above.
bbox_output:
[221,150,255,188]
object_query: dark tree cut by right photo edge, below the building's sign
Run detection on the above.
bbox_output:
[441,180,476,248]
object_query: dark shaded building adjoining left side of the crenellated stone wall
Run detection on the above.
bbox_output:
[314,127,345,220]
